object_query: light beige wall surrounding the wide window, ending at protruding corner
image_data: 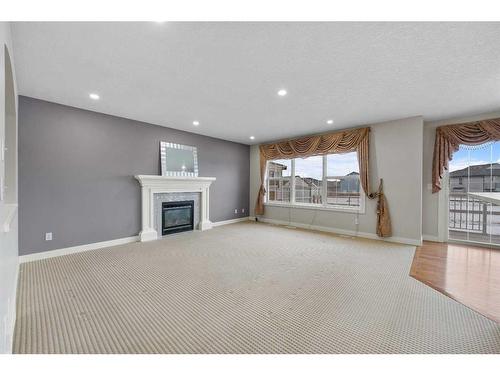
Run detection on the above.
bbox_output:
[250,117,423,244]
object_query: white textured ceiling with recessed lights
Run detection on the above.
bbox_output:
[9,22,500,144]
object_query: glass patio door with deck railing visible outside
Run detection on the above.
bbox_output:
[448,142,500,245]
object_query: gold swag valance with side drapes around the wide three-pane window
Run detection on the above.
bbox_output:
[255,127,391,237]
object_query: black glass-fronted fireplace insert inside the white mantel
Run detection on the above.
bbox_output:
[161,201,194,236]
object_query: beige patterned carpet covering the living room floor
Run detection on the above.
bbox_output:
[14,222,500,353]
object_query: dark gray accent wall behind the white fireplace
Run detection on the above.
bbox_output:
[19,96,250,255]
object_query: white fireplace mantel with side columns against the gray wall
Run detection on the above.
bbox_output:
[135,175,215,241]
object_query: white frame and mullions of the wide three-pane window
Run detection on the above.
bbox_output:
[264,155,366,214]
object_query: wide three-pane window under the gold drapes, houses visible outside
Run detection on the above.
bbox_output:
[267,152,364,211]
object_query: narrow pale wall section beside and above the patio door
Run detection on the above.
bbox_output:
[422,112,500,241]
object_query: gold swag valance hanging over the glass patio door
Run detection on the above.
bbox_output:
[432,118,500,193]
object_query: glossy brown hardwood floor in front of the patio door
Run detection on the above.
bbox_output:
[410,241,500,323]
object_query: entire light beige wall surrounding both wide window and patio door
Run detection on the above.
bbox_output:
[250,111,500,247]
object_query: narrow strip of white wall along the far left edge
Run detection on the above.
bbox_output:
[0,22,19,353]
